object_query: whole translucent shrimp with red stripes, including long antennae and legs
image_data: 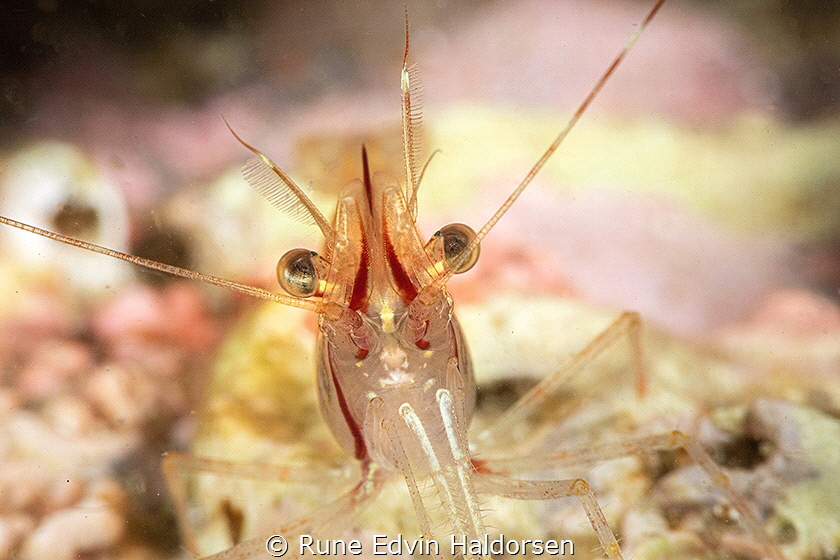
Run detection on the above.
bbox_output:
[0,0,783,560]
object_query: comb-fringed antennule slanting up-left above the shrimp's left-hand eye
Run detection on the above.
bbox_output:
[222,117,335,245]
